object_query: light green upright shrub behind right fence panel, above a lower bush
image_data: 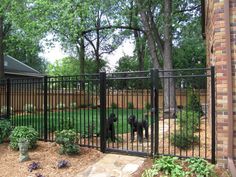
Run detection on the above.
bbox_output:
[177,110,201,132]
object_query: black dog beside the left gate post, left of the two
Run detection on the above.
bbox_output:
[106,113,117,142]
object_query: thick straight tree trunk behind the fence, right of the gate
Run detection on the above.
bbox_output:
[163,0,176,116]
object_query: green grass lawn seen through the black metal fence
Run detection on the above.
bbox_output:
[11,109,149,136]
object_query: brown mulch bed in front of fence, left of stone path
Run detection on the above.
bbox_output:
[0,142,103,177]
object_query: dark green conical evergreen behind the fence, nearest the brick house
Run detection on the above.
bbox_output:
[188,91,203,116]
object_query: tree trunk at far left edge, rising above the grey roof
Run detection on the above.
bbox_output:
[0,16,4,79]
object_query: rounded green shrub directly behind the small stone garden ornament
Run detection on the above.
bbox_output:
[10,126,39,150]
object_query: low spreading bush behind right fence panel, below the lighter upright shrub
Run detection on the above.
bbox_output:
[171,129,199,149]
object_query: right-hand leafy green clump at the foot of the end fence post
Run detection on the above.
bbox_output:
[186,158,216,177]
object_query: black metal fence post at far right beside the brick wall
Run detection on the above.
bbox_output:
[211,66,216,164]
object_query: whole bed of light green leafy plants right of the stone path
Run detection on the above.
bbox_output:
[142,156,217,177]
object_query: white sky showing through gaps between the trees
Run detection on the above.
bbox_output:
[40,37,134,70]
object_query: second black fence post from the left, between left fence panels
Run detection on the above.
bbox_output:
[43,76,48,141]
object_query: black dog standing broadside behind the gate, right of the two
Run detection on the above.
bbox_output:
[128,115,148,143]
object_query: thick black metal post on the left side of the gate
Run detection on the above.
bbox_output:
[100,72,106,153]
